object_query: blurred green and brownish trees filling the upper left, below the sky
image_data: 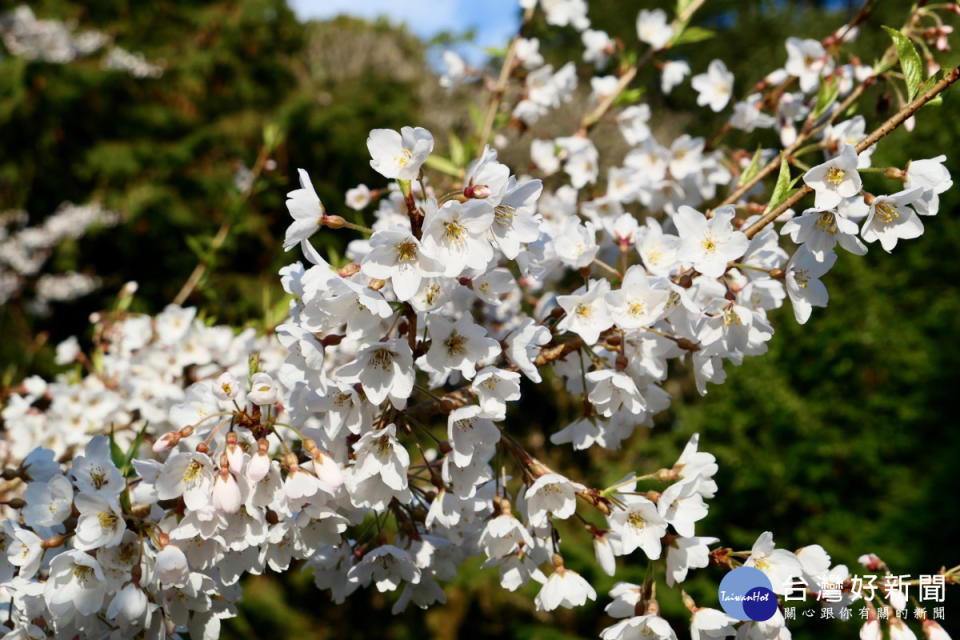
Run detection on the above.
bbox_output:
[0,0,436,381]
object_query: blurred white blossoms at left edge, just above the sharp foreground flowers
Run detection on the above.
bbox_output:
[0,202,120,313]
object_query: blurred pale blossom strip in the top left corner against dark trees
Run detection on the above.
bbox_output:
[0,4,164,78]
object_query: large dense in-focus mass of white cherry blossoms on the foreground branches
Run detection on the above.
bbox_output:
[0,0,960,640]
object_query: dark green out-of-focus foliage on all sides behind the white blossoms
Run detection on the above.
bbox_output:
[0,0,960,640]
